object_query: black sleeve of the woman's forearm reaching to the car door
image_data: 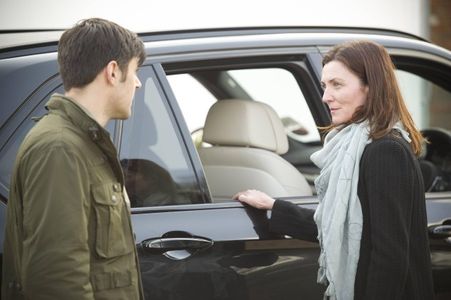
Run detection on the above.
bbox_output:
[269,200,318,242]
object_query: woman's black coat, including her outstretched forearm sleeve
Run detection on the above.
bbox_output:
[270,134,434,300]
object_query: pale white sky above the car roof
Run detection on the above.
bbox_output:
[0,0,429,37]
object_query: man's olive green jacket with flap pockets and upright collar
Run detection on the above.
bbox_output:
[2,94,143,300]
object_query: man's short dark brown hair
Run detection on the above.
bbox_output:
[58,18,146,91]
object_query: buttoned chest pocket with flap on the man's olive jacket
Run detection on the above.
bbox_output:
[92,182,134,258]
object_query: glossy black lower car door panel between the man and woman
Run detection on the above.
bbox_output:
[132,203,324,299]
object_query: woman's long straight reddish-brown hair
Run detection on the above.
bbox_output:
[323,40,423,155]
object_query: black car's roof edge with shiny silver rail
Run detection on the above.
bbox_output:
[0,26,451,64]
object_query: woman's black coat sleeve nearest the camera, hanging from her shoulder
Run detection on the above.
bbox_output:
[360,140,415,299]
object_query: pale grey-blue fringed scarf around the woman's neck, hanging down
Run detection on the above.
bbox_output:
[310,122,410,300]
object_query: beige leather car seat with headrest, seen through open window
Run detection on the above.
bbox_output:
[199,99,312,201]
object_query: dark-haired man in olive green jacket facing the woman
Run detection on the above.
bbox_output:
[2,19,145,300]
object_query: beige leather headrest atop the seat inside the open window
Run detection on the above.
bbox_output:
[203,99,288,154]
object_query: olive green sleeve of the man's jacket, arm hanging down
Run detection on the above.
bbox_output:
[20,146,93,300]
